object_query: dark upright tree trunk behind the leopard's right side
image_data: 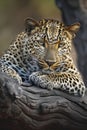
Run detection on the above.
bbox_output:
[56,0,87,86]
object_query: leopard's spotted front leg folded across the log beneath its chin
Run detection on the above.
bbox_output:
[29,72,85,96]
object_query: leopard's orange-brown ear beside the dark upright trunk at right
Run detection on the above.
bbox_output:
[65,22,80,36]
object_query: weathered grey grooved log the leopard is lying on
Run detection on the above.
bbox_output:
[0,73,87,130]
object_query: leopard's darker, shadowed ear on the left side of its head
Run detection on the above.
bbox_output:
[25,18,39,33]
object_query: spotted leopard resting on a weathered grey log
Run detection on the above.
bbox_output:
[0,18,86,97]
